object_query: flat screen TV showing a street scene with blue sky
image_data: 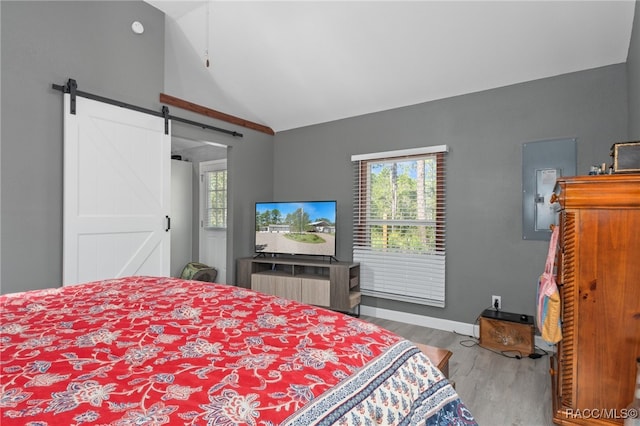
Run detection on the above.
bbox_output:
[255,201,336,257]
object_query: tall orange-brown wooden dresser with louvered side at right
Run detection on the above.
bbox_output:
[551,174,640,425]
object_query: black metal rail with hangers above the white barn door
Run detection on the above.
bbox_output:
[51,78,242,138]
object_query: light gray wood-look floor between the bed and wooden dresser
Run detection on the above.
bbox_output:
[361,315,553,426]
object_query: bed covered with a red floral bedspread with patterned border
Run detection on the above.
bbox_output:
[0,277,476,426]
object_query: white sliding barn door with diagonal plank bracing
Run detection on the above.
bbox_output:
[63,94,171,285]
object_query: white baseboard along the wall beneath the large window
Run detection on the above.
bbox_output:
[360,305,555,352]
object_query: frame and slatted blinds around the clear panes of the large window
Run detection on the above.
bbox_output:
[352,145,448,307]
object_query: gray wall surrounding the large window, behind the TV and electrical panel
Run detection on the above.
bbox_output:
[273,64,628,323]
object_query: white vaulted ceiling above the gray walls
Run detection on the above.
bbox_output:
[146,0,635,131]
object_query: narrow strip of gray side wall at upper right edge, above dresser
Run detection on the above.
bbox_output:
[627,1,640,141]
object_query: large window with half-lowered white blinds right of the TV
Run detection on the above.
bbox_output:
[351,145,448,307]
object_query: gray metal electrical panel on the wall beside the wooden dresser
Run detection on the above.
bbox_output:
[522,138,576,240]
